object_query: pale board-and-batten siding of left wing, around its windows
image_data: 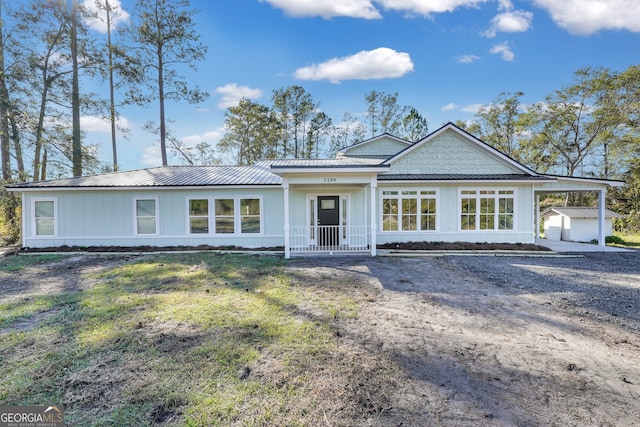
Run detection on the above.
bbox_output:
[23,188,284,248]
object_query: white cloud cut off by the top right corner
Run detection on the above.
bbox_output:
[534,0,640,35]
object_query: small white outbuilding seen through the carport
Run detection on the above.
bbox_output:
[541,207,622,242]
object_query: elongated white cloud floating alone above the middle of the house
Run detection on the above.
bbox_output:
[295,47,413,83]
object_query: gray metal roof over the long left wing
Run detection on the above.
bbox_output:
[8,165,282,189]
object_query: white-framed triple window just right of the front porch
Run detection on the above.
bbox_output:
[382,190,436,231]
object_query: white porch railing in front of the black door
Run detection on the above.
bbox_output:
[289,225,371,252]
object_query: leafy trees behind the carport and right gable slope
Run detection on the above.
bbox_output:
[457,65,640,232]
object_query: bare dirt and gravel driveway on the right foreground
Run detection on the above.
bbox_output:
[289,253,640,426]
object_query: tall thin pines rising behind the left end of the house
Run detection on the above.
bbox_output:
[0,0,207,181]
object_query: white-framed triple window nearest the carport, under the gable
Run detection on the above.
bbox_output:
[460,190,515,231]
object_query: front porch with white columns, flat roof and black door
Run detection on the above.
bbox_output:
[271,158,389,258]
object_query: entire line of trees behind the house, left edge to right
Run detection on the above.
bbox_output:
[0,0,640,234]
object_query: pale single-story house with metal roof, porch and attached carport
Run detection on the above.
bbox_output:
[8,123,623,257]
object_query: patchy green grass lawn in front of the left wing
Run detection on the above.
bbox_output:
[0,254,372,426]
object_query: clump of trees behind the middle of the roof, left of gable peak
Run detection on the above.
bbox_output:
[214,86,428,165]
